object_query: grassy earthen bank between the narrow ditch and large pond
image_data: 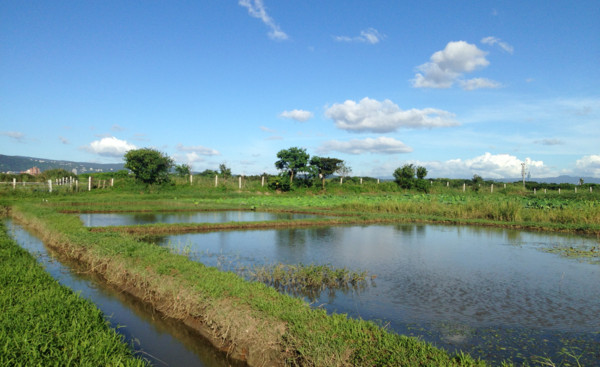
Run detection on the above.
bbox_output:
[11,203,485,366]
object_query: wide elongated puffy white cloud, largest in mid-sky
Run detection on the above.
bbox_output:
[325,97,458,133]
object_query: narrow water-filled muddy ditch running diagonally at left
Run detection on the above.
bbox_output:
[7,221,245,367]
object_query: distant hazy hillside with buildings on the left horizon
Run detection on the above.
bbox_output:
[0,154,124,175]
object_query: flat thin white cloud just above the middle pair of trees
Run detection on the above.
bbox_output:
[318,137,412,154]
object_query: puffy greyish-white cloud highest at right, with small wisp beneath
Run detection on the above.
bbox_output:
[412,41,499,90]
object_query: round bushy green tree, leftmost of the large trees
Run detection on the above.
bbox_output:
[124,148,174,185]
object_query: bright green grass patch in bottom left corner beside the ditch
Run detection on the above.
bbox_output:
[0,221,146,366]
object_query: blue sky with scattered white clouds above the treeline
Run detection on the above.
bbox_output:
[0,0,600,178]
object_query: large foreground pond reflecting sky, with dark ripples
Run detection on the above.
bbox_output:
[156,224,600,365]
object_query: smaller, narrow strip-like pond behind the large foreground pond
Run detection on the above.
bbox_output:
[79,211,318,227]
